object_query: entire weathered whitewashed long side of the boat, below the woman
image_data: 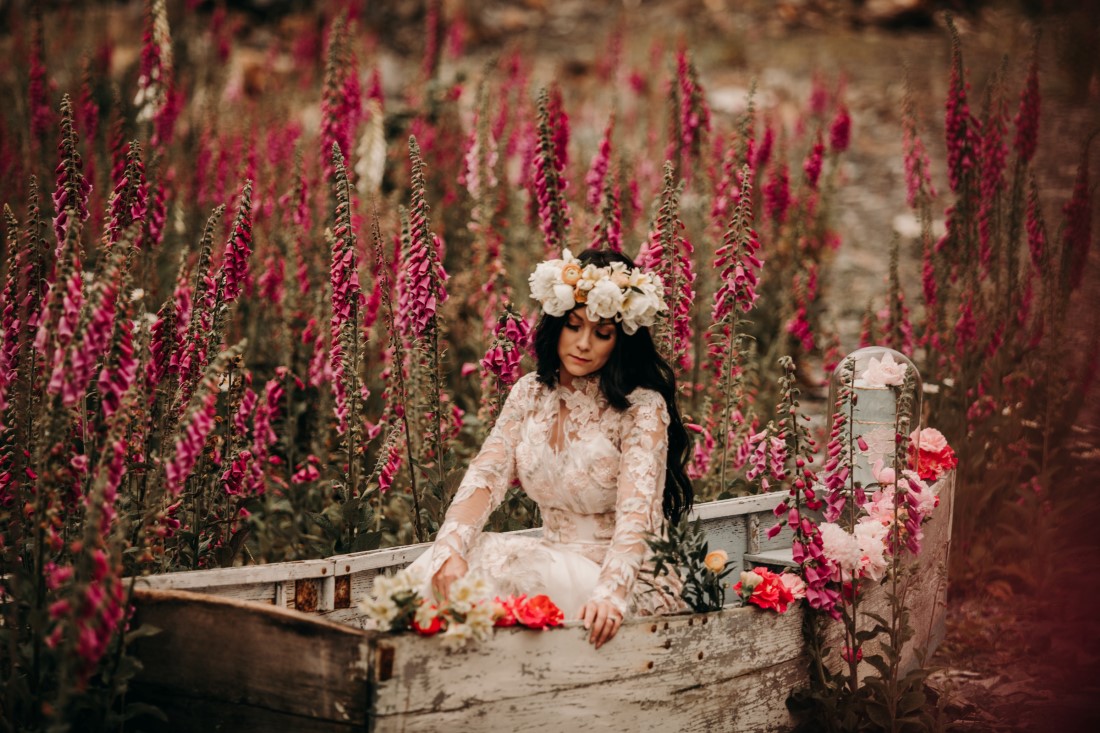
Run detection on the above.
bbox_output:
[373,609,805,733]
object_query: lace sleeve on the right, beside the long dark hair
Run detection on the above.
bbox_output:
[592,390,669,615]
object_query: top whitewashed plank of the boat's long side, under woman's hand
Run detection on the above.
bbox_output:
[374,608,803,717]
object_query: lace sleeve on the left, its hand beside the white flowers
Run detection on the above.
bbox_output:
[430,374,538,576]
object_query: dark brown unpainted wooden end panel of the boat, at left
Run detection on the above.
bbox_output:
[131,590,371,731]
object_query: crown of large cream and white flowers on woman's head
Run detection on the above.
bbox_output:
[528,250,667,333]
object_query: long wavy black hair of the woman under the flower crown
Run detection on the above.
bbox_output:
[535,250,695,524]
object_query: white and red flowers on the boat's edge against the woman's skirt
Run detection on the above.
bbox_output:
[359,568,563,652]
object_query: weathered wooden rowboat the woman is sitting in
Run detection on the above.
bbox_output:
[131,474,954,733]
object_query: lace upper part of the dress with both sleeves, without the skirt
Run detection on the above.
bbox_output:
[431,373,669,613]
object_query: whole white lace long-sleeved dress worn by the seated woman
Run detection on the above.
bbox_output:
[416,373,685,620]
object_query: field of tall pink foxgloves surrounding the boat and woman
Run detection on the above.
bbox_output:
[0,0,1100,724]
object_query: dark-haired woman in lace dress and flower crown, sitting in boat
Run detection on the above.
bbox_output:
[417,250,693,648]
